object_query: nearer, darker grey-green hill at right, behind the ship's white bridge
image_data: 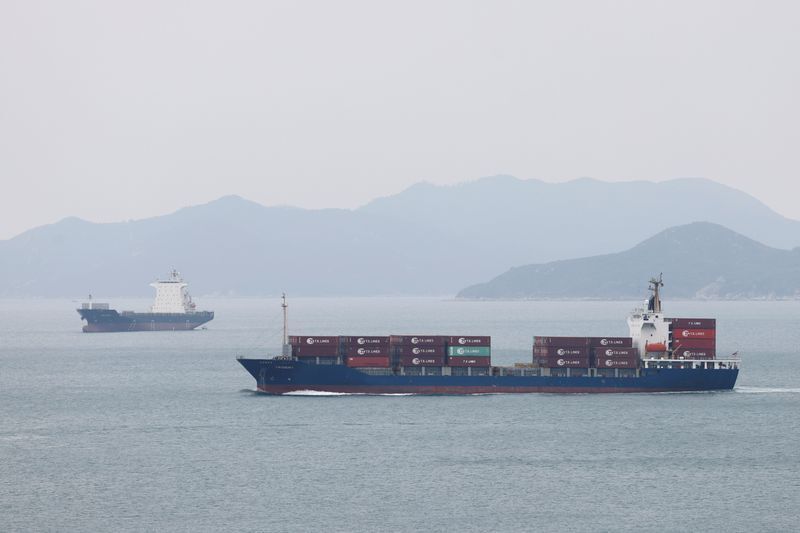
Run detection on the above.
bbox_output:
[458,222,800,298]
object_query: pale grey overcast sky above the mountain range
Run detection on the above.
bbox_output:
[0,0,800,238]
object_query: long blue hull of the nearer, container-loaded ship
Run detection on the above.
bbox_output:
[239,359,739,394]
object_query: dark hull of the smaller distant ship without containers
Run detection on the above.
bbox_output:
[78,309,214,333]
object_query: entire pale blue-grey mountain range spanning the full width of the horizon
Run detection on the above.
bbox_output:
[0,176,800,297]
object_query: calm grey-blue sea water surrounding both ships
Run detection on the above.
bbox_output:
[0,298,800,532]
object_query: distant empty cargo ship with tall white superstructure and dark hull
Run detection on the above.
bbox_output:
[77,270,214,333]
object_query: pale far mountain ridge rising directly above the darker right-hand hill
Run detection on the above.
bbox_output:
[361,176,800,266]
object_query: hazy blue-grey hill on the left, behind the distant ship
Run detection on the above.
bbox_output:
[0,196,454,296]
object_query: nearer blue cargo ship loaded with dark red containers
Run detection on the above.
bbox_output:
[237,276,740,394]
